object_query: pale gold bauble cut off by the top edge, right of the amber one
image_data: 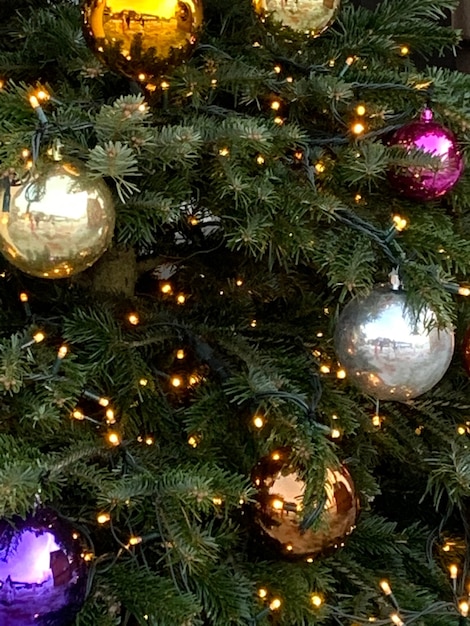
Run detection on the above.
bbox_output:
[253,0,341,36]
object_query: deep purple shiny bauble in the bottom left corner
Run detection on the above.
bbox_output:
[0,509,88,626]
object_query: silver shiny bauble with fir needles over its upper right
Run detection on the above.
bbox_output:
[334,287,454,401]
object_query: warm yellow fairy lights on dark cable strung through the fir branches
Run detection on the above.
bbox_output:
[0,42,470,626]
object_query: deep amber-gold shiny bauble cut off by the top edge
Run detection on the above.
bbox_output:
[82,0,203,83]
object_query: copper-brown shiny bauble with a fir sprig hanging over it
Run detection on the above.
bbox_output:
[253,448,359,557]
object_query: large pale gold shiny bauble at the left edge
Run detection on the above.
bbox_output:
[0,162,115,278]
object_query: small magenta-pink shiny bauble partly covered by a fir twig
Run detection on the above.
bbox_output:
[389,109,463,200]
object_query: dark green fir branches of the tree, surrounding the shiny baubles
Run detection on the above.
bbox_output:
[0,0,470,626]
